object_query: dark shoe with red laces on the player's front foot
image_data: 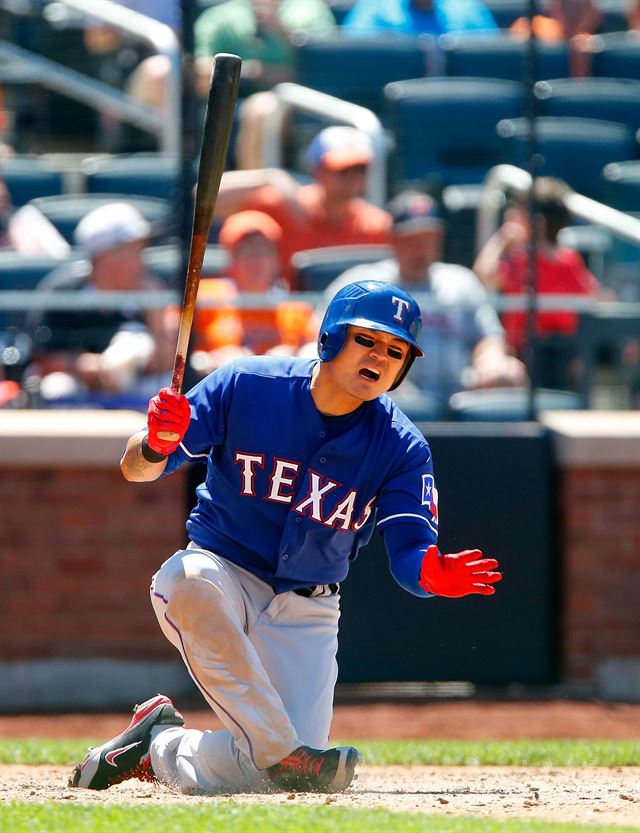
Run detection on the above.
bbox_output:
[267,746,362,793]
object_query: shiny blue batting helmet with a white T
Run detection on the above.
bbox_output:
[318,281,424,390]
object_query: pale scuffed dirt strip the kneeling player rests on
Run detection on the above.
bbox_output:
[0,765,640,829]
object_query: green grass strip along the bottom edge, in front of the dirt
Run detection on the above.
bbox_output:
[0,800,639,833]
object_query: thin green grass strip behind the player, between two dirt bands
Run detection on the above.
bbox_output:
[0,739,640,766]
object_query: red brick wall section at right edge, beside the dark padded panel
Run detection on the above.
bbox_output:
[560,468,640,682]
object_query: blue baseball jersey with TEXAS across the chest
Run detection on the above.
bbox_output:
[164,356,438,595]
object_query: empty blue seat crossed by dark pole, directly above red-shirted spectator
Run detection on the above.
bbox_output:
[497,116,637,200]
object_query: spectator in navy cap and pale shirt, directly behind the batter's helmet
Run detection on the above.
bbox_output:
[325,191,526,414]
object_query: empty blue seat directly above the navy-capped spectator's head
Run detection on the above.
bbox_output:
[385,78,524,185]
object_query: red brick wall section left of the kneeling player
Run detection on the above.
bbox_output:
[0,458,187,661]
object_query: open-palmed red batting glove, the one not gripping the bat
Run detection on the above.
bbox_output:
[418,544,502,599]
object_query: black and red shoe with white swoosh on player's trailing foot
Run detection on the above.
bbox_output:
[69,694,184,790]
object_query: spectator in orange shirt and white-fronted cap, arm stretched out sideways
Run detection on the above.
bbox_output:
[216,126,390,288]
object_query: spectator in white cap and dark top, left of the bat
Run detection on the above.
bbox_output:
[28,202,177,404]
